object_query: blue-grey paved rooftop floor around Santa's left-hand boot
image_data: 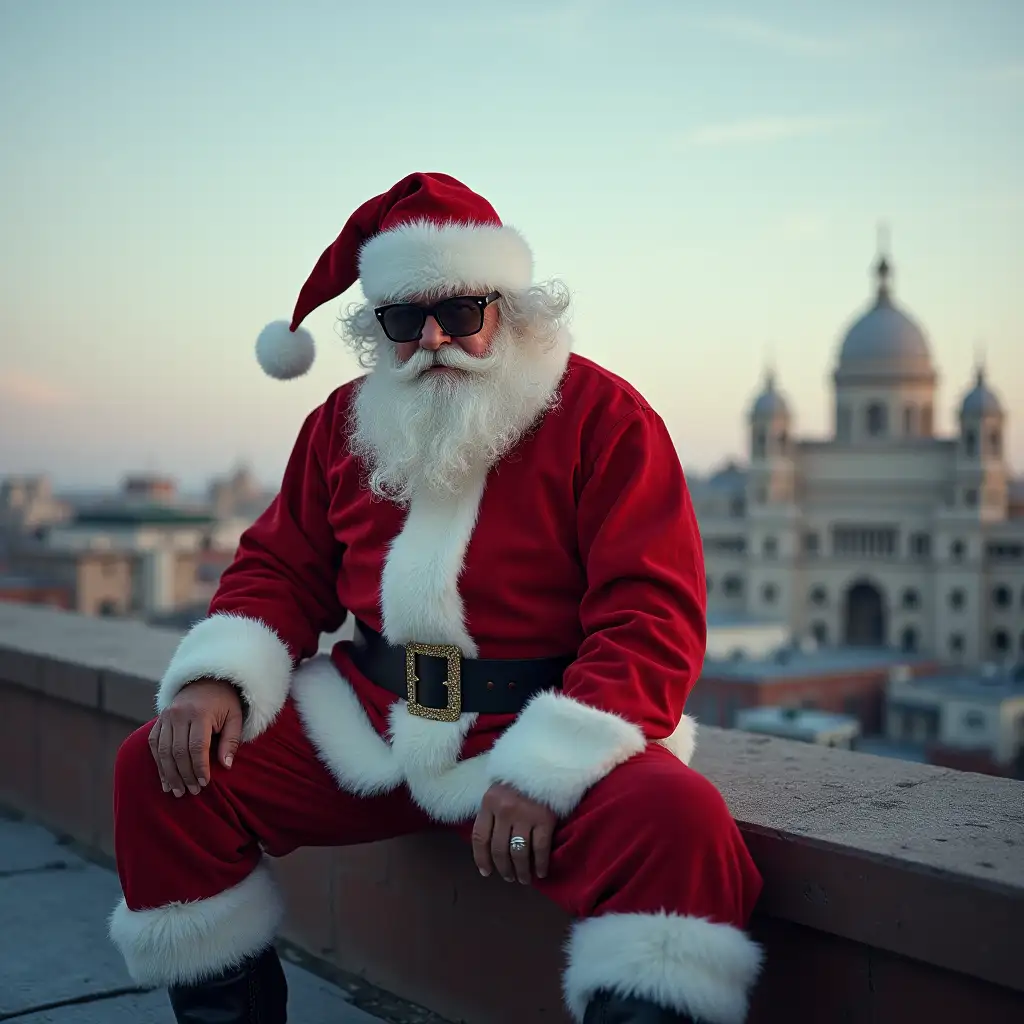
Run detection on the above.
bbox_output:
[0,818,381,1024]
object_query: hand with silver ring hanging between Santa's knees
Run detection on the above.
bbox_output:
[473,782,557,886]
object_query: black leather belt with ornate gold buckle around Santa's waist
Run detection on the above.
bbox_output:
[349,622,575,722]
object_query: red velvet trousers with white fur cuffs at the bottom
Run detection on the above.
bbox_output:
[112,700,761,1024]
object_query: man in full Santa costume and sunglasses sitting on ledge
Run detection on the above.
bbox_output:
[111,174,761,1024]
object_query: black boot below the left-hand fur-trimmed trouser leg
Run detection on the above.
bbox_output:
[167,946,288,1024]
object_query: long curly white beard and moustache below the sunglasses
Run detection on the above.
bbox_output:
[349,327,567,506]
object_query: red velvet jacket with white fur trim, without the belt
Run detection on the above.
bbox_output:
[159,354,706,820]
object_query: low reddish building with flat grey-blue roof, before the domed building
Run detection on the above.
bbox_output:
[686,646,939,735]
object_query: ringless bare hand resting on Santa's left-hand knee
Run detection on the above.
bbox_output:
[150,679,244,797]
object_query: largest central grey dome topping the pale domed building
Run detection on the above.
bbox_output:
[836,257,935,380]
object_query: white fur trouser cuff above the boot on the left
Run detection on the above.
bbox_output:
[110,863,285,986]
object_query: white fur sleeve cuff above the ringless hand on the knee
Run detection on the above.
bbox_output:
[157,614,292,740]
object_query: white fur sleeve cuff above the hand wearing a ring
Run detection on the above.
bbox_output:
[488,690,647,817]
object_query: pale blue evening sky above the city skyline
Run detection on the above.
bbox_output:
[0,0,1024,485]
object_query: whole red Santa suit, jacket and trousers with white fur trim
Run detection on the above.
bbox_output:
[112,176,760,1024]
